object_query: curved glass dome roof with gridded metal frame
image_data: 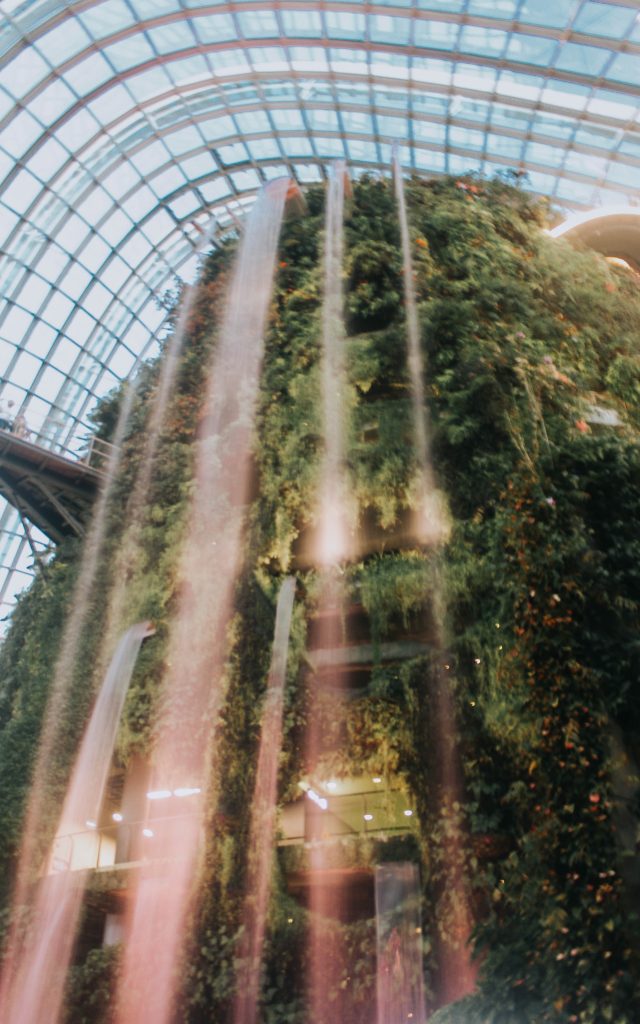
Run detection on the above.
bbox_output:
[0,0,640,615]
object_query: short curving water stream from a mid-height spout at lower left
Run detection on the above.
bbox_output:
[2,623,148,1024]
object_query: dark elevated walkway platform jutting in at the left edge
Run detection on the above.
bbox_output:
[0,429,102,544]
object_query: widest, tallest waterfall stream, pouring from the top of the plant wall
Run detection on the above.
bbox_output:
[116,179,290,1024]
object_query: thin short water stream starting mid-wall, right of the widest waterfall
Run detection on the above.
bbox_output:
[233,577,296,1024]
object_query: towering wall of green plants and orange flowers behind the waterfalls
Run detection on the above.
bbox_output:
[0,177,640,1024]
